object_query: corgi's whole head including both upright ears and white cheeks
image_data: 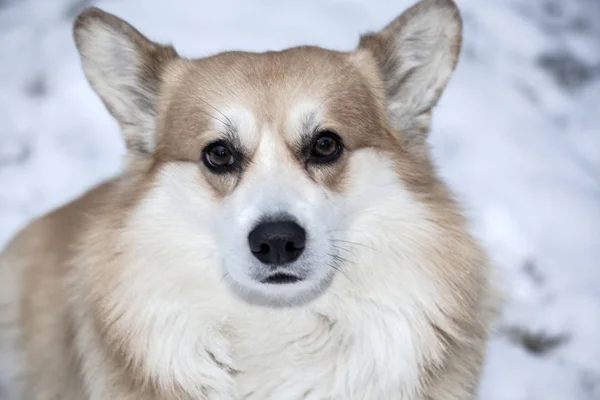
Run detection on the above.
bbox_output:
[74,0,461,305]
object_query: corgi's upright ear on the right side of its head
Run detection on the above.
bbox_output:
[358,0,462,141]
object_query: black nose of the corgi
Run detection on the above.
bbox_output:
[248,221,306,265]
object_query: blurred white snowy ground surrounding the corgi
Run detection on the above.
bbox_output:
[0,0,600,400]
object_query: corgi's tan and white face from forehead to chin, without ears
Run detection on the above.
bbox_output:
[150,48,404,303]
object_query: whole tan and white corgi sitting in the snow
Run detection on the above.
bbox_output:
[0,0,494,400]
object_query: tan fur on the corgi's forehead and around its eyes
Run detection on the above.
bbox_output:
[156,47,394,196]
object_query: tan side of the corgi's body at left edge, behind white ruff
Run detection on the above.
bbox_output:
[0,182,118,399]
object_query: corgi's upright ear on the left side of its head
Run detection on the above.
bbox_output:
[73,7,177,153]
